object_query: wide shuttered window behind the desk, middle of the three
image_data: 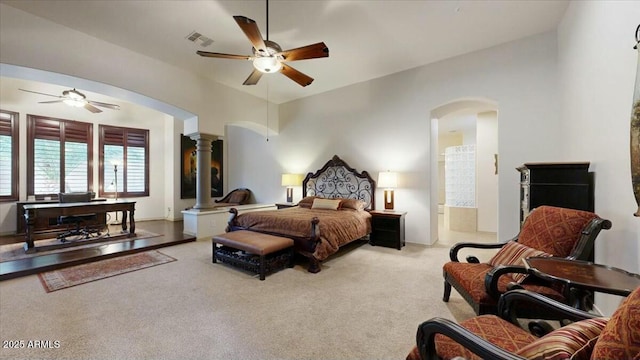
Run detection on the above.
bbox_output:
[27,115,93,197]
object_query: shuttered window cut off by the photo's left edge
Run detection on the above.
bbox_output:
[0,110,20,201]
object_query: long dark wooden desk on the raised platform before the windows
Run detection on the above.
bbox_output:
[24,199,136,253]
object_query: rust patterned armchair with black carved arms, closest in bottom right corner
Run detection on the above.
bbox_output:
[407,288,640,360]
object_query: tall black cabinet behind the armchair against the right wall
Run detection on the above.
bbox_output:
[516,162,594,225]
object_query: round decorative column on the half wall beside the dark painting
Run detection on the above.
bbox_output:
[189,133,217,210]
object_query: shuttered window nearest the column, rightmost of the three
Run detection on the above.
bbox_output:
[100,125,149,198]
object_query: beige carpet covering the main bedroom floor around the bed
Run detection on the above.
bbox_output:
[0,241,473,359]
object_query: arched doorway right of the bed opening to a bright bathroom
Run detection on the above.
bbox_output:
[430,98,498,245]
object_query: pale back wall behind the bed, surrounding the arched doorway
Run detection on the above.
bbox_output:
[226,33,562,244]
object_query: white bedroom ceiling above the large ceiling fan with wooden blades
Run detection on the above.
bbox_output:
[1,0,569,103]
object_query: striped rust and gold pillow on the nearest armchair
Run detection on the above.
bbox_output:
[516,318,609,360]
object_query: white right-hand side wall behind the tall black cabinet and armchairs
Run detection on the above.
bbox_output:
[557,1,640,313]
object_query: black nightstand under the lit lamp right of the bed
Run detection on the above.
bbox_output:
[369,210,407,250]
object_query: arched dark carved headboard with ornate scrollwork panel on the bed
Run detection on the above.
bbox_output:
[302,155,376,210]
